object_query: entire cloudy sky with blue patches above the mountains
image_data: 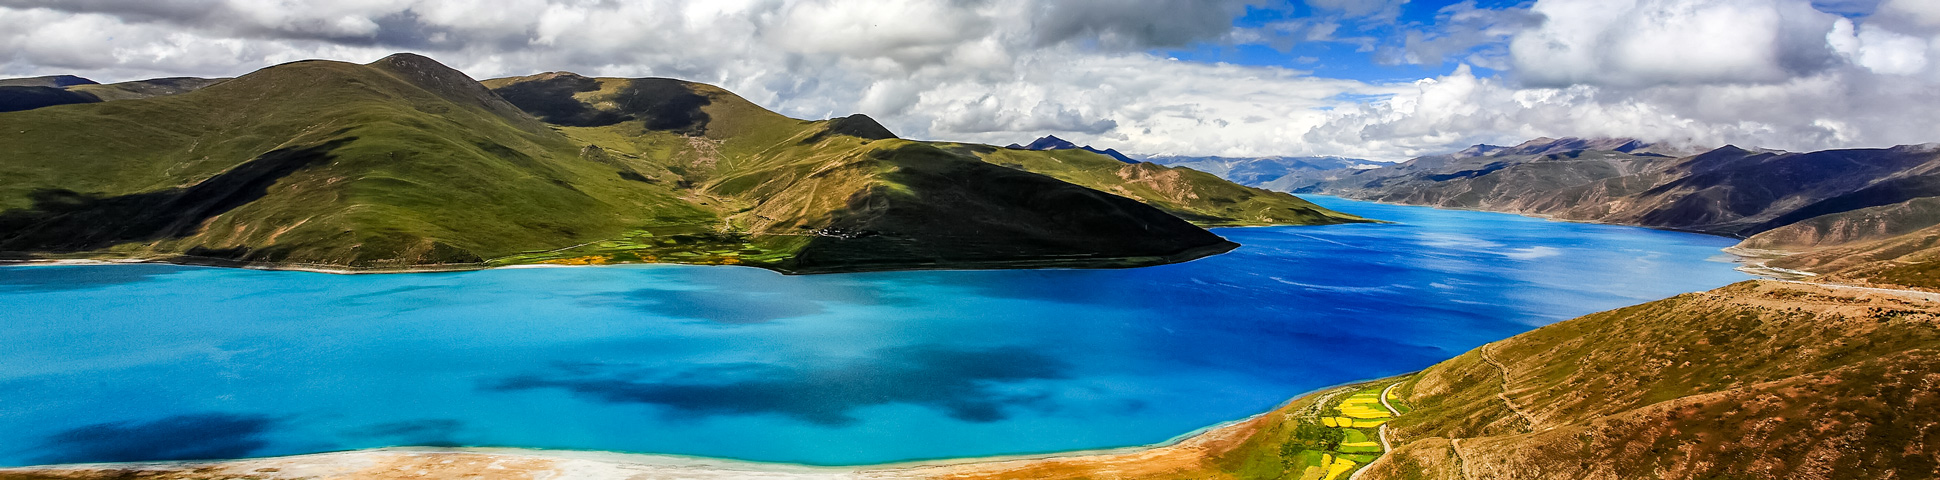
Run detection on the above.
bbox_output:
[0,0,1940,159]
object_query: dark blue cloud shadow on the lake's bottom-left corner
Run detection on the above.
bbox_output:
[37,414,275,463]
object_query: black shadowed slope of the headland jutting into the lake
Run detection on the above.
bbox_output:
[776,144,1232,270]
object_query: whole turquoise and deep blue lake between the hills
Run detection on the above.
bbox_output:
[0,196,1748,464]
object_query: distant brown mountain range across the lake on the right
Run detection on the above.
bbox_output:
[1228,138,1940,288]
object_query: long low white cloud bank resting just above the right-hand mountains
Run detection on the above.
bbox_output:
[1304,56,1940,157]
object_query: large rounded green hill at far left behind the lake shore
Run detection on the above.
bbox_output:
[0,54,710,268]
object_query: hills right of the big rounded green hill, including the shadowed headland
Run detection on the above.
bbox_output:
[485,72,1362,272]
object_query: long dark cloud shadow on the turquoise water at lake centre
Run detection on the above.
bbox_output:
[485,346,1069,426]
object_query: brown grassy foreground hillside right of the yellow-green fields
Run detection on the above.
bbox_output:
[1364,282,1940,478]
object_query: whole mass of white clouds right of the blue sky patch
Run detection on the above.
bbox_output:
[1302,0,1940,157]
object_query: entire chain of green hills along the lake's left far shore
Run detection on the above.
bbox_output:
[0,54,1364,272]
